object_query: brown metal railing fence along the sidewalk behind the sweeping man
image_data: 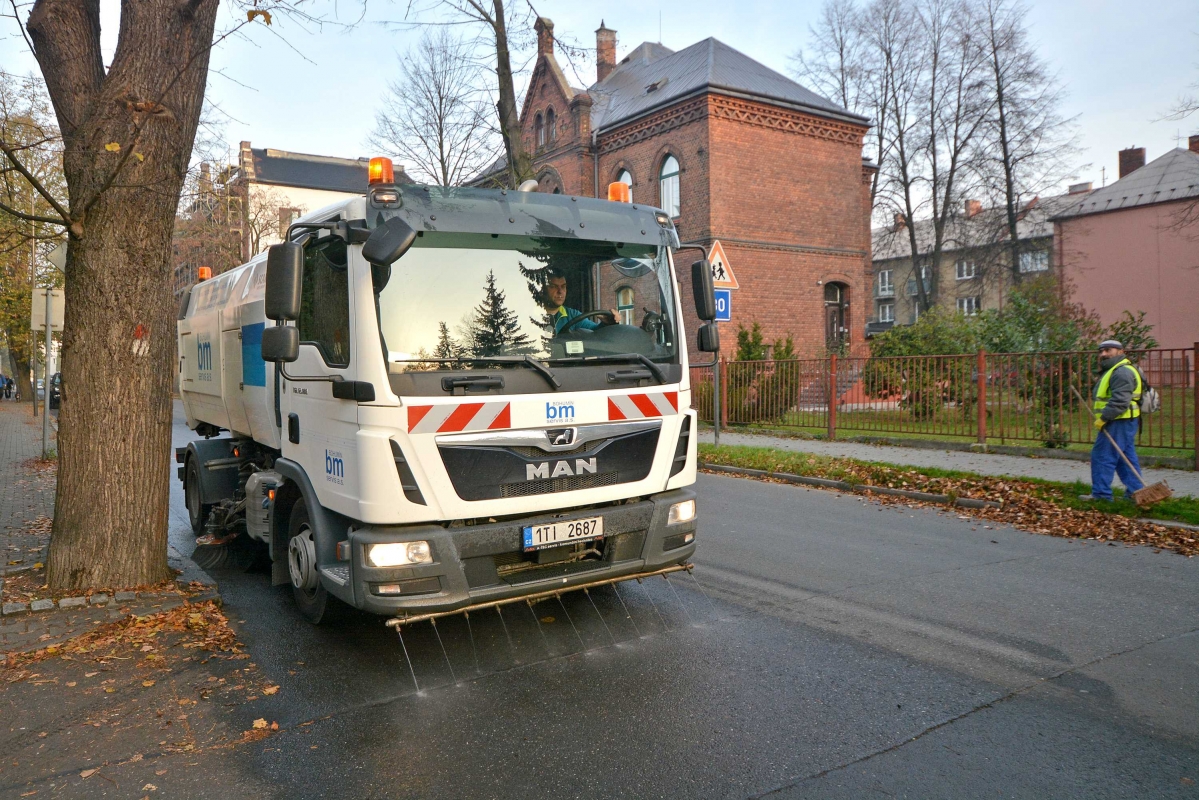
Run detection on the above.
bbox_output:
[692,345,1199,467]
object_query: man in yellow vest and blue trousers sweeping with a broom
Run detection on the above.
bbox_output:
[1081,339,1145,500]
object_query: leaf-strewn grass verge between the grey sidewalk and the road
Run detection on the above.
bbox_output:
[699,443,1199,525]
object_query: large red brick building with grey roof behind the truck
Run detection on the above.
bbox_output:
[478,18,873,356]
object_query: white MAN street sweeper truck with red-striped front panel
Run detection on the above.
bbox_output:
[176,172,716,621]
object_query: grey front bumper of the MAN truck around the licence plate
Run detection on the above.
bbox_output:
[326,488,697,615]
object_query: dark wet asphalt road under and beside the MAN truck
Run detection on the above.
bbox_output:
[171,415,1199,798]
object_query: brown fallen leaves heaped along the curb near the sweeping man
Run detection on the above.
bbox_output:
[700,445,1199,557]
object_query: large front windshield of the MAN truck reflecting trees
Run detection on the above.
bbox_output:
[379,233,679,372]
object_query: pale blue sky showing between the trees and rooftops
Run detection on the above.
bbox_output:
[0,0,1199,186]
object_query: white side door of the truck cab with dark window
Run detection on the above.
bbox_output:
[279,236,359,516]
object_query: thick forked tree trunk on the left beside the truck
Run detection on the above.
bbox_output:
[28,0,217,589]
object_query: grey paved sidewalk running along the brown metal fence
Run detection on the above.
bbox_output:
[699,429,1199,498]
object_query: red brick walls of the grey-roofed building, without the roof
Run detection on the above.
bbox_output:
[522,25,872,357]
